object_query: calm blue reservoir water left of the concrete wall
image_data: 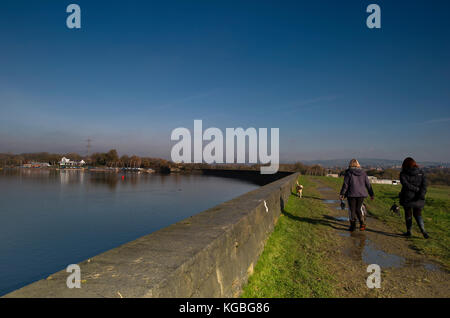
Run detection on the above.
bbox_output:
[0,169,258,295]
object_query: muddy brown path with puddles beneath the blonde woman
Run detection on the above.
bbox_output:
[313,179,450,298]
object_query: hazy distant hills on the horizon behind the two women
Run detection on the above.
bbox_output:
[301,158,450,168]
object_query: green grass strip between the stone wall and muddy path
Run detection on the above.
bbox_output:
[242,176,334,298]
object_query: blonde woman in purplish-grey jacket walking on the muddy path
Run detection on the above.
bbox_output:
[339,159,374,231]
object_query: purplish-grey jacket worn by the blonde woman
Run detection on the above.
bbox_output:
[341,168,374,198]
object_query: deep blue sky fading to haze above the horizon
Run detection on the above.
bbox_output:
[0,0,450,162]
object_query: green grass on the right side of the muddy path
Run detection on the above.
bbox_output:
[320,177,450,267]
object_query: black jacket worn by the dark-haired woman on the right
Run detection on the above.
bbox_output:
[399,168,427,208]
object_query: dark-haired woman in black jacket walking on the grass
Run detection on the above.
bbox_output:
[399,157,429,239]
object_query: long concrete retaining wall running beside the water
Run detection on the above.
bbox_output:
[5,174,298,297]
